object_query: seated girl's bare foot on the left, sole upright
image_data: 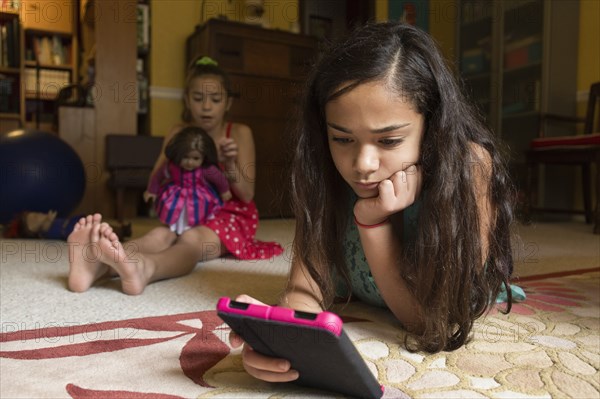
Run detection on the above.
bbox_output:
[67,213,108,292]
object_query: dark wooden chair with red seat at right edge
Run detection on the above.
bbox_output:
[524,82,600,234]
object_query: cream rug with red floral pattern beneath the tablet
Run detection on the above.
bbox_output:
[0,271,600,399]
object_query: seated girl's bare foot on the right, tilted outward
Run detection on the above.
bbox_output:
[98,223,152,295]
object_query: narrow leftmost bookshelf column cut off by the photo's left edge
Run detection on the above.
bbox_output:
[0,5,24,134]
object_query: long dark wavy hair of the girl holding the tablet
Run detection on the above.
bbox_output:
[291,22,514,352]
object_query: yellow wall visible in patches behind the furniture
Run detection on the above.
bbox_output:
[150,0,600,135]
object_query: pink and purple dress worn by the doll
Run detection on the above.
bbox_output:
[148,162,229,234]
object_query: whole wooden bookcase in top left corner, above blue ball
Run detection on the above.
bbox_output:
[0,0,77,133]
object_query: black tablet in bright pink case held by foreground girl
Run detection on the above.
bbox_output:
[217,297,383,399]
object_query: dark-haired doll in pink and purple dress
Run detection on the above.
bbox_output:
[144,126,232,234]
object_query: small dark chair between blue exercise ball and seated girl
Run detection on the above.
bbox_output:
[106,134,163,224]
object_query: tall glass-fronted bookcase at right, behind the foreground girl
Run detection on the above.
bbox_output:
[457,0,579,206]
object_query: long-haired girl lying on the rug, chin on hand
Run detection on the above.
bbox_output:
[234,22,513,381]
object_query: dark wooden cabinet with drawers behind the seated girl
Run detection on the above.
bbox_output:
[186,19,317,218]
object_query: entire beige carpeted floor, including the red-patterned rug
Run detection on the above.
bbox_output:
[0,220,600,399]
